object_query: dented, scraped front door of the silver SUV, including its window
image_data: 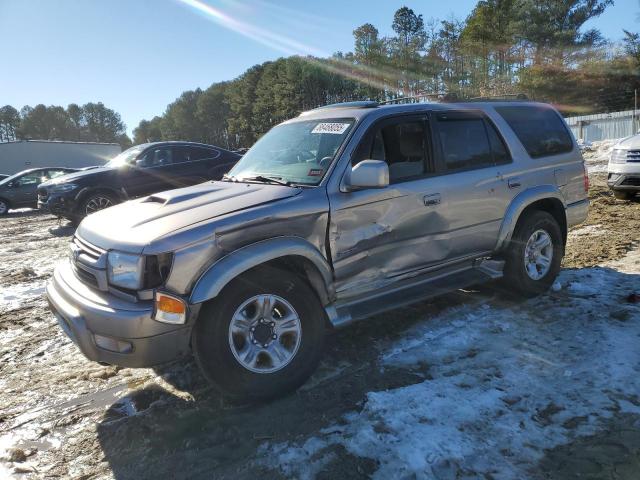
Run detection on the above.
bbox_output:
[329,114,449,297]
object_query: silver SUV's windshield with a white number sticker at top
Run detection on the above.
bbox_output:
[229,118,354,185]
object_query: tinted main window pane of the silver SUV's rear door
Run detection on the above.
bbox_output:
[438,115,494,171]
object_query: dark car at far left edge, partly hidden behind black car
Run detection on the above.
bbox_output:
[0,167,75,215]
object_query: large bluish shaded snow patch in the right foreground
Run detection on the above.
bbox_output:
[266,254,640,479]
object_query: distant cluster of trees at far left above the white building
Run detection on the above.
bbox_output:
[0,102,131,148]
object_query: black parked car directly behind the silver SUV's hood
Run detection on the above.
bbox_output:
[38,142,240,221]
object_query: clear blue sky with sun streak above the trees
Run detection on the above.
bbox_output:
[0,0,640,133]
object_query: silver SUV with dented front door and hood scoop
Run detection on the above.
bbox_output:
[47,102,588,400]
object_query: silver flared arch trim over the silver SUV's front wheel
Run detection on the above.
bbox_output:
[189,237,333,304]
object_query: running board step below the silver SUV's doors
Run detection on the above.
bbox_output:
[326,259,504,328]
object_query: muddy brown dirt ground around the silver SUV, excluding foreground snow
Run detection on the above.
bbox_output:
[0,175,640,480]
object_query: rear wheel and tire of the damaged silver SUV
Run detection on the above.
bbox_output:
[502,211,564,297]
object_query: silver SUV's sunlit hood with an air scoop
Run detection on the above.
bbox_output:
[77,182,301,253]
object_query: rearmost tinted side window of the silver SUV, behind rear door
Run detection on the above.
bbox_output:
[496,105,573,158]
